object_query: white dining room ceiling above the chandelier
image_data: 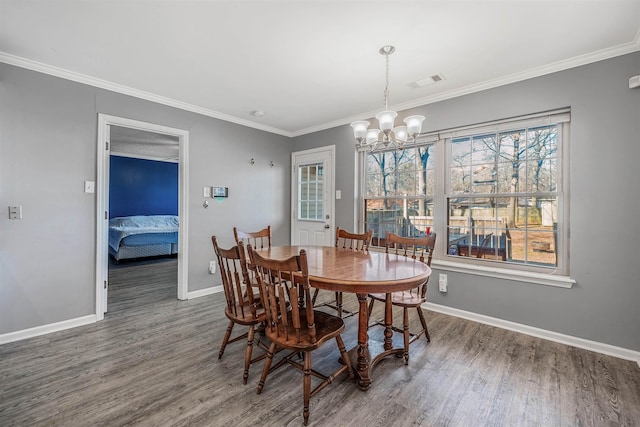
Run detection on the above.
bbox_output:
[0,0,640,136]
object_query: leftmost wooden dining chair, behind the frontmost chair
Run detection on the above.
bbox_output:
[211,236,267,384]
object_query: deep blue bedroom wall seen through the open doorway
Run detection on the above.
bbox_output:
[109,156,178,218]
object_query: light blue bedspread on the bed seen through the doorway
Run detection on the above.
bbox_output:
[109,215,178,251]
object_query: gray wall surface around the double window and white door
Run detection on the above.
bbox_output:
[294,53,640,351]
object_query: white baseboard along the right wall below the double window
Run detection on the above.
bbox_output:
[422,302,640,366]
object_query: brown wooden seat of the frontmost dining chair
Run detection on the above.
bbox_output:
[265,310,344,351]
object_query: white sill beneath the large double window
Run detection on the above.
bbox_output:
[431,259,576,289]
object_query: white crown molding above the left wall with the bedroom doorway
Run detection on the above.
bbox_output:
[0,52,292,137]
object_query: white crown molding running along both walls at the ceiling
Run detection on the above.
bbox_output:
[0,31,640,138]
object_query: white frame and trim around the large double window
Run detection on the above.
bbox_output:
[358,108,575,288]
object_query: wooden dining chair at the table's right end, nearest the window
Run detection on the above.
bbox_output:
[369,231,436,365]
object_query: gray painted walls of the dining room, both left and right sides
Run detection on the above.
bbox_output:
[0,53,640,351]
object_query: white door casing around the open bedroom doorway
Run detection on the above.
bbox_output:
[96,114,189,320]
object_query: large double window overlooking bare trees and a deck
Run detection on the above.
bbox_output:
[363,109,570,273]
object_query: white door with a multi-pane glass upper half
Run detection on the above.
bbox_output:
[291,145,335,246]
